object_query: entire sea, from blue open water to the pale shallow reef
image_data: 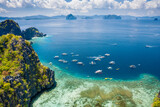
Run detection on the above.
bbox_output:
[4,19,160,107]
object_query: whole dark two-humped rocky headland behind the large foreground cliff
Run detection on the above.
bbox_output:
[0,20,46,40]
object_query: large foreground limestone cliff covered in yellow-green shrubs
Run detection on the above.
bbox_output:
[0,34,55,107]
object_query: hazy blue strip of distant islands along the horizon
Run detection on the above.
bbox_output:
[0,14,160,20]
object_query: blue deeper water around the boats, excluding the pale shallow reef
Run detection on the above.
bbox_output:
[7,19,160,80]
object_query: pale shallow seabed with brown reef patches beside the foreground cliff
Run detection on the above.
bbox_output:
[31,63,160,107]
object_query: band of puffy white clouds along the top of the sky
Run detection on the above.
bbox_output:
[0,0,160,12]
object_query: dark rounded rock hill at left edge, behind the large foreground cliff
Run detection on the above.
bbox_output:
[0,20,21,36]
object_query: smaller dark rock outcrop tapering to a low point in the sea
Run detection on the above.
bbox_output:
[22,27,46,40]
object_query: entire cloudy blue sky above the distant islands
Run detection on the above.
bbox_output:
[0,0,160,17]
